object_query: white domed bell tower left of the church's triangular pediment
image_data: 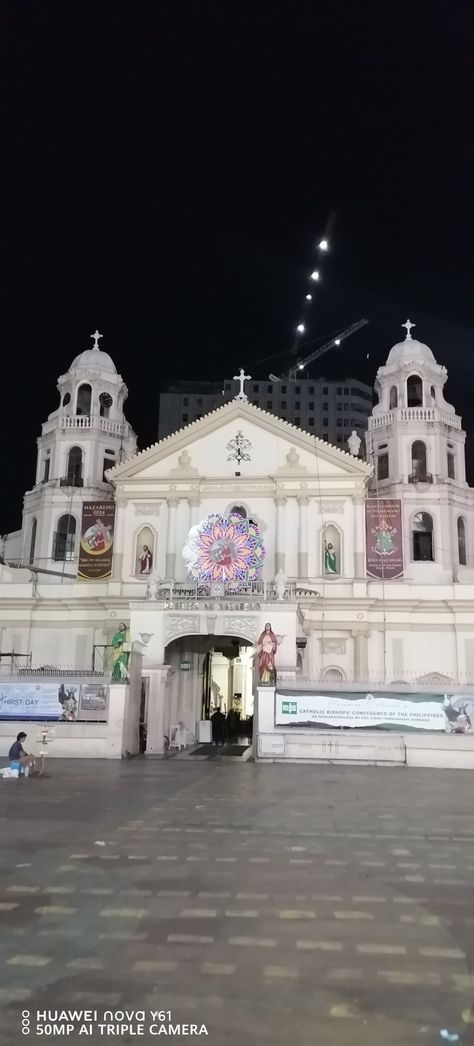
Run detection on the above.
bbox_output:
[21,331,136,582]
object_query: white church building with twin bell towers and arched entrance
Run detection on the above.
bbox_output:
[0,321,474,768]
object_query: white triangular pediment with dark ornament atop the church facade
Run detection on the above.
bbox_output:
[108,400,371,486]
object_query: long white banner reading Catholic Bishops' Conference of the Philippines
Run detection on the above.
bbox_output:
[275,690,474,733]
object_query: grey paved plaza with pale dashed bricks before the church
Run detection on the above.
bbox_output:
[0,758,474,1046]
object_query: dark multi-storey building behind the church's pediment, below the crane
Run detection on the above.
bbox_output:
[158,378,373,447]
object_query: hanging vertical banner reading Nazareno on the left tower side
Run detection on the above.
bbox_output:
[77,501,115,582]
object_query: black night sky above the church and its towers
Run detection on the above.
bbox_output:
[0,0,474,532]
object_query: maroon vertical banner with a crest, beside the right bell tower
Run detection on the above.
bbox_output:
[365,498,403,581]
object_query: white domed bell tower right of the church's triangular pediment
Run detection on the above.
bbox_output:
[367,320,466,583]
